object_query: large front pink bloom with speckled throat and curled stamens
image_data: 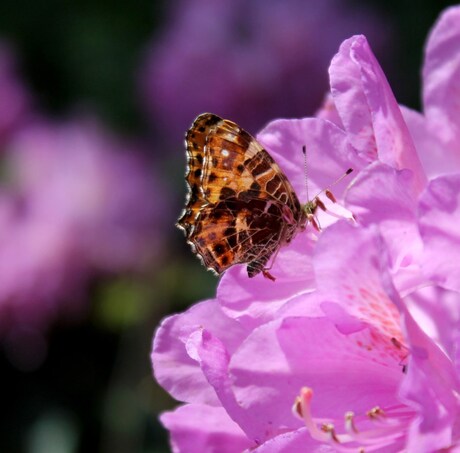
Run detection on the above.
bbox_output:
[152,221,460,452]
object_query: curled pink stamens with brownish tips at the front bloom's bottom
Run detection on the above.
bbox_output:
[292,387,415,453]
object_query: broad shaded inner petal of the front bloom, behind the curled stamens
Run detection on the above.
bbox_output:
[230,317,402,440]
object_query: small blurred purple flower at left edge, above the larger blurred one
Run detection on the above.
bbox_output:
[0,42,31,146]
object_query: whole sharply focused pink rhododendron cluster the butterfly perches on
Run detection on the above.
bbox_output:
[152,7,460,453]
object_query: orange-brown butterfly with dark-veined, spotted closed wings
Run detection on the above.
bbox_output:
[177,113,348,280]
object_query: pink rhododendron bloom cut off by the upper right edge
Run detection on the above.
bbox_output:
[398,6,460,291]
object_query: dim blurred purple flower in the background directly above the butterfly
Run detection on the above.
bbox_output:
[141,0,391,146]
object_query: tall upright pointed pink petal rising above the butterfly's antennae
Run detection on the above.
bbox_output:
[329,36,425,191]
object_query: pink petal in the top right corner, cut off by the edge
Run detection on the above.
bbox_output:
[423,6,460,148]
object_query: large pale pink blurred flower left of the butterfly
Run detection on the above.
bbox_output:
[0,121,166,364]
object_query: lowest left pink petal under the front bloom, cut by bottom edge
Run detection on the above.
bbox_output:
[160,404,254,453]
